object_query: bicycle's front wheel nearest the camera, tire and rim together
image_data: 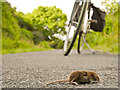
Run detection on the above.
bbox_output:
[63,2,89,56]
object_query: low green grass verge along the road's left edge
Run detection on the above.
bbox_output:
[0,41,53,54]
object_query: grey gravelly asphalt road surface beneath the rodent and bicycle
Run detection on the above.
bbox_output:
[2,50,118,88]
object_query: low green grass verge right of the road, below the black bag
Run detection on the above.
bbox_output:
[73,32,118,54]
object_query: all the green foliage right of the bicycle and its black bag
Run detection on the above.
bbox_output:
[84,0,118,54]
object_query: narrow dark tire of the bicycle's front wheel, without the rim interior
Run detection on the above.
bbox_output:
[64,2,88,56]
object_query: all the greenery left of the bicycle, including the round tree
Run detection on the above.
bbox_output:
[2,2,67,54]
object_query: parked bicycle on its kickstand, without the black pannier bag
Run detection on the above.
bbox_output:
[63,0,105,56]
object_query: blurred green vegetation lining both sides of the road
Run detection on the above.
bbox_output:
[1,0,120,54]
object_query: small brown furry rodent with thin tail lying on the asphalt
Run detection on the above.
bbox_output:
[47,71,100,85]
